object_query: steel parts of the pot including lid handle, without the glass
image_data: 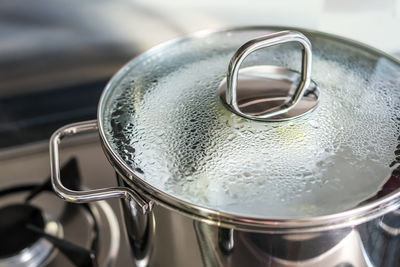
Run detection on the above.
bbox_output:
[50,27,400,266]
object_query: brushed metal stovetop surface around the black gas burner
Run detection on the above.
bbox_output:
[0,137,133,267]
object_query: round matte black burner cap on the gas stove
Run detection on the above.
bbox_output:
[0,204,45,258]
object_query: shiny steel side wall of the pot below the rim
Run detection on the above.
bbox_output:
[117,174,400,266]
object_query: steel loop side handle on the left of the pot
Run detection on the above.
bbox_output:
[50,120,153,214]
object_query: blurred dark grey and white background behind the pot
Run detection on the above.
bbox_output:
[0,0,400,148]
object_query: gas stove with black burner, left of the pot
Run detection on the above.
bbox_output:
[0,135,133,267]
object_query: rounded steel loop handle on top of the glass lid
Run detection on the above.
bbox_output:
[225,31,312,121]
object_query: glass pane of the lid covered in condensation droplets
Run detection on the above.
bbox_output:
[102,30,400,218]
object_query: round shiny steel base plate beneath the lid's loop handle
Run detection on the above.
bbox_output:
[219,66,320,121]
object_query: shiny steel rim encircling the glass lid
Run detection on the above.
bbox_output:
[97,26,400,233]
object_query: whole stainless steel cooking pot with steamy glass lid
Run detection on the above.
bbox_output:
[50,27,400,266]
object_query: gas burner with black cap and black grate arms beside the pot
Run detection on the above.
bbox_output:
[0,158,115,267]
